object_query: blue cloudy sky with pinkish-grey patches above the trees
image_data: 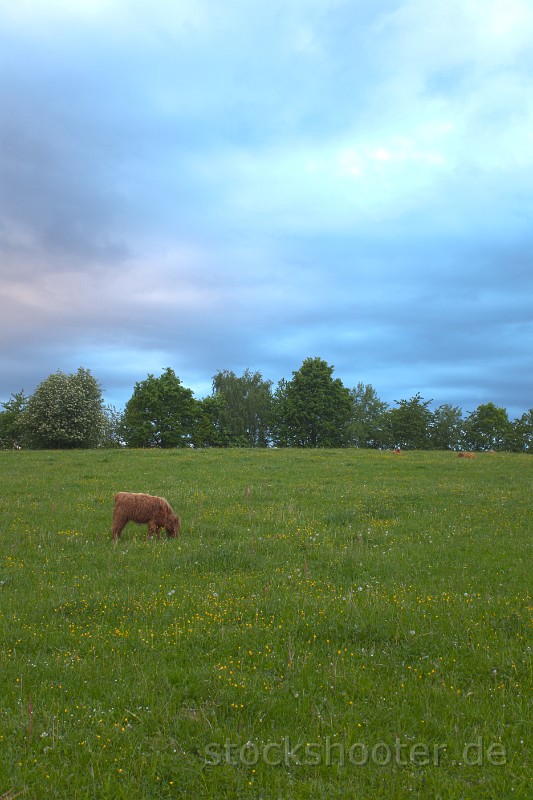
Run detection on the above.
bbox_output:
[0,0,533,417]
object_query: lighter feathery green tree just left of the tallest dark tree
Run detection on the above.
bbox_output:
[213,369,272,447]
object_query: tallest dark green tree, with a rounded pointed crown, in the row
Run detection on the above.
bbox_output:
[275,358,353,447]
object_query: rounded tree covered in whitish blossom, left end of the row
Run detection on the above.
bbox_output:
[24,367,103,449]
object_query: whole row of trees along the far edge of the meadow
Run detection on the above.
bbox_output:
[0,357,533,452]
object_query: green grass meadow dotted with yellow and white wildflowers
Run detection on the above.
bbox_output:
[0,450,533,800]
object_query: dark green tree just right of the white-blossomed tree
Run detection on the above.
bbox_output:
[121,367,198,448]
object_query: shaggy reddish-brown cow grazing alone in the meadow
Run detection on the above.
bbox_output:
[113,492,181,539]
